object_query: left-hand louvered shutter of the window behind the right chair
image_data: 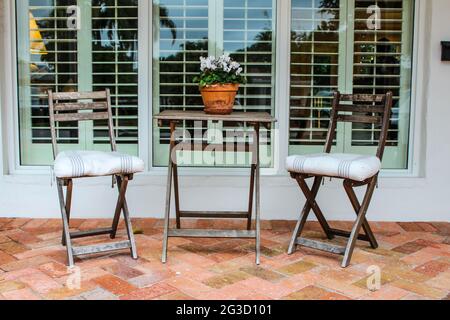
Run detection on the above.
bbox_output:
[289,0,342,153]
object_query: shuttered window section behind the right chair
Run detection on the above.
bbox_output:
[289,0,414,169]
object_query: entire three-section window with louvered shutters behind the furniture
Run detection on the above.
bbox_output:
[16,0,415,169]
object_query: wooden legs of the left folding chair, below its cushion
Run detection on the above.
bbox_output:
[57,175,137,267]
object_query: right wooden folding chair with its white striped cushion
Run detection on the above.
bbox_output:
[286,92,392,268]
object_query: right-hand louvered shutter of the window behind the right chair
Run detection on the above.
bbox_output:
[349,0,413,168]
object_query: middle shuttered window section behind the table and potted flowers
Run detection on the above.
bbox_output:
[153,0,276,166]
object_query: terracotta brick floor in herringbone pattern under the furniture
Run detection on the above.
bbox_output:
[0,219,450,300]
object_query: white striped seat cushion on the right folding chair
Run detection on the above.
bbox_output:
[286,153,381,181]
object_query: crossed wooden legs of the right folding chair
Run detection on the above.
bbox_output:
[288,173,378,268]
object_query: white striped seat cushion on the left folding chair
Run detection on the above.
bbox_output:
[54,151,144,178]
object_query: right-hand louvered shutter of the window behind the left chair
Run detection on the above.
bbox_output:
[92,0,138,154]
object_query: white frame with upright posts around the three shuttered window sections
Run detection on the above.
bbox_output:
[2,0,422,178]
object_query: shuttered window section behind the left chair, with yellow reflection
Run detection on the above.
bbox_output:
[16,0,138,165]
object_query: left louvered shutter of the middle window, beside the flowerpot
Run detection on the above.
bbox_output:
[153,0,208,166]
